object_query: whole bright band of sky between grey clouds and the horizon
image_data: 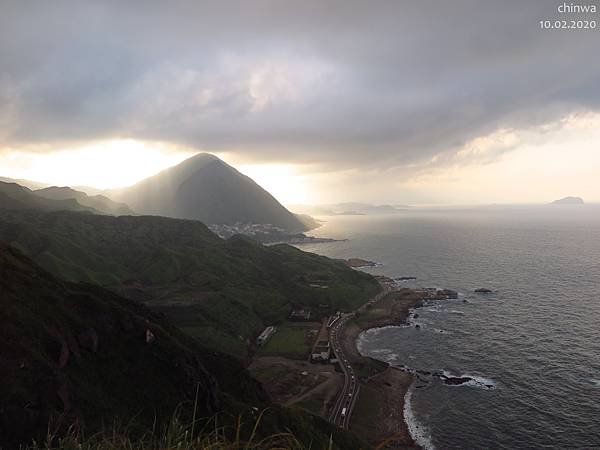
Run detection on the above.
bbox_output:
[0,112,600,206]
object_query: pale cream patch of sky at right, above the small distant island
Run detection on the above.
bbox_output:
[399,112,600,204]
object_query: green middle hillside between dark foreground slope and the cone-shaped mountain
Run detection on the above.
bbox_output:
[0,211,379,356]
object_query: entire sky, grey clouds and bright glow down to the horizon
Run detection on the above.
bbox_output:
[0,0,600,204]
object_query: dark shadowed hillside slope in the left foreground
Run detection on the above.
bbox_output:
[0,244,360,449]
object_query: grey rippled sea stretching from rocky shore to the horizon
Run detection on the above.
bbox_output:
[302,205,600,449]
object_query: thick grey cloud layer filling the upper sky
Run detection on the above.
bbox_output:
[0,0,600,167]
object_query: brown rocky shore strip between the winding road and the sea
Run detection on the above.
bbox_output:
[342,288,427,449]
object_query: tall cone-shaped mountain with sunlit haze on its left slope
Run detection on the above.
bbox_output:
[109,153,308,232]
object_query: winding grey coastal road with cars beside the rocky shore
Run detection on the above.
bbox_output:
[329,288,389,428]
